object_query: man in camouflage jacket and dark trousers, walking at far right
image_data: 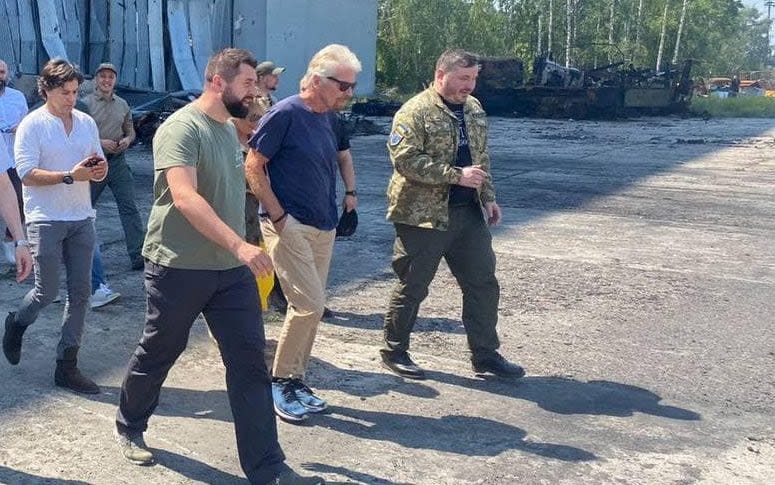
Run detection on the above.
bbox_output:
[381,50,525,379]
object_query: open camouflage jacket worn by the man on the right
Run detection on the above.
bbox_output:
[387,86,495,230]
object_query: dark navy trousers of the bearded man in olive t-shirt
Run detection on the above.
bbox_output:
[116,261,286,484]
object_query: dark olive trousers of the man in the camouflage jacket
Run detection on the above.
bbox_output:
[384,204,500,360]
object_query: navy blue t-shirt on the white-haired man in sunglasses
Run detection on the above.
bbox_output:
[248,95,339,231]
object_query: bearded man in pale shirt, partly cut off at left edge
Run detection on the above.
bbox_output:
[0,59,27,263]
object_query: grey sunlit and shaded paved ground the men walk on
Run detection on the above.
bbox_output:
[0,118,775,484]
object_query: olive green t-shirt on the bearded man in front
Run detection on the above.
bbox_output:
[143,104,245,270]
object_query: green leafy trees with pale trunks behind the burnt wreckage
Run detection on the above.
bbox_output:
[377,0,770,92]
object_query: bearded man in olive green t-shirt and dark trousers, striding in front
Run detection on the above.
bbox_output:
[116,49,323,484]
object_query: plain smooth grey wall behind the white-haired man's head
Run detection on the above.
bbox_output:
[264,0,377,98]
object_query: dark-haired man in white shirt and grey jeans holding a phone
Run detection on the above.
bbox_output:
[3,59,108,394]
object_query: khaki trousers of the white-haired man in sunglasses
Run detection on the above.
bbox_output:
[261,214,336,379]
